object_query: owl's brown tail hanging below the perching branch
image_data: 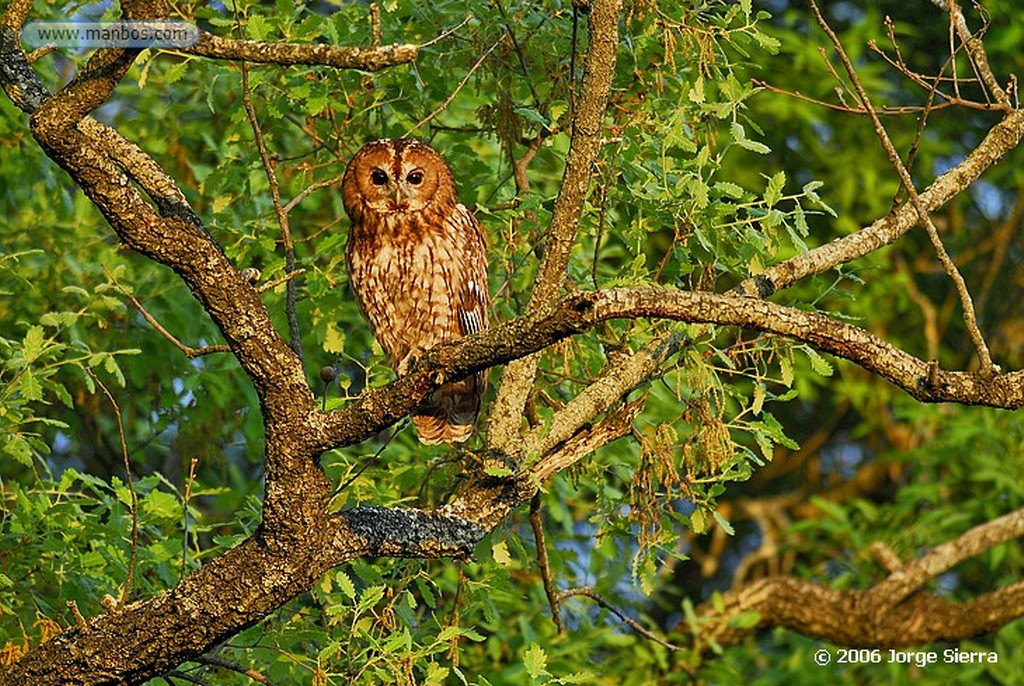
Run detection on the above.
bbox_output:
[413,375,485,445]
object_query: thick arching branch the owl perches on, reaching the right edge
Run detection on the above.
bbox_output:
[315,288,1024,458]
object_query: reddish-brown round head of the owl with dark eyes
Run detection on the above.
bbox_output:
[342,138,458,219]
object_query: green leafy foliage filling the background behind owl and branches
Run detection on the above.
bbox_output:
[0,0,1024,684]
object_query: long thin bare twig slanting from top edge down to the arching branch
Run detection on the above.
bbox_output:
[810,0,999,377]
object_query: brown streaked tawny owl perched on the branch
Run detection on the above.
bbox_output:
[342,138,488,443]
